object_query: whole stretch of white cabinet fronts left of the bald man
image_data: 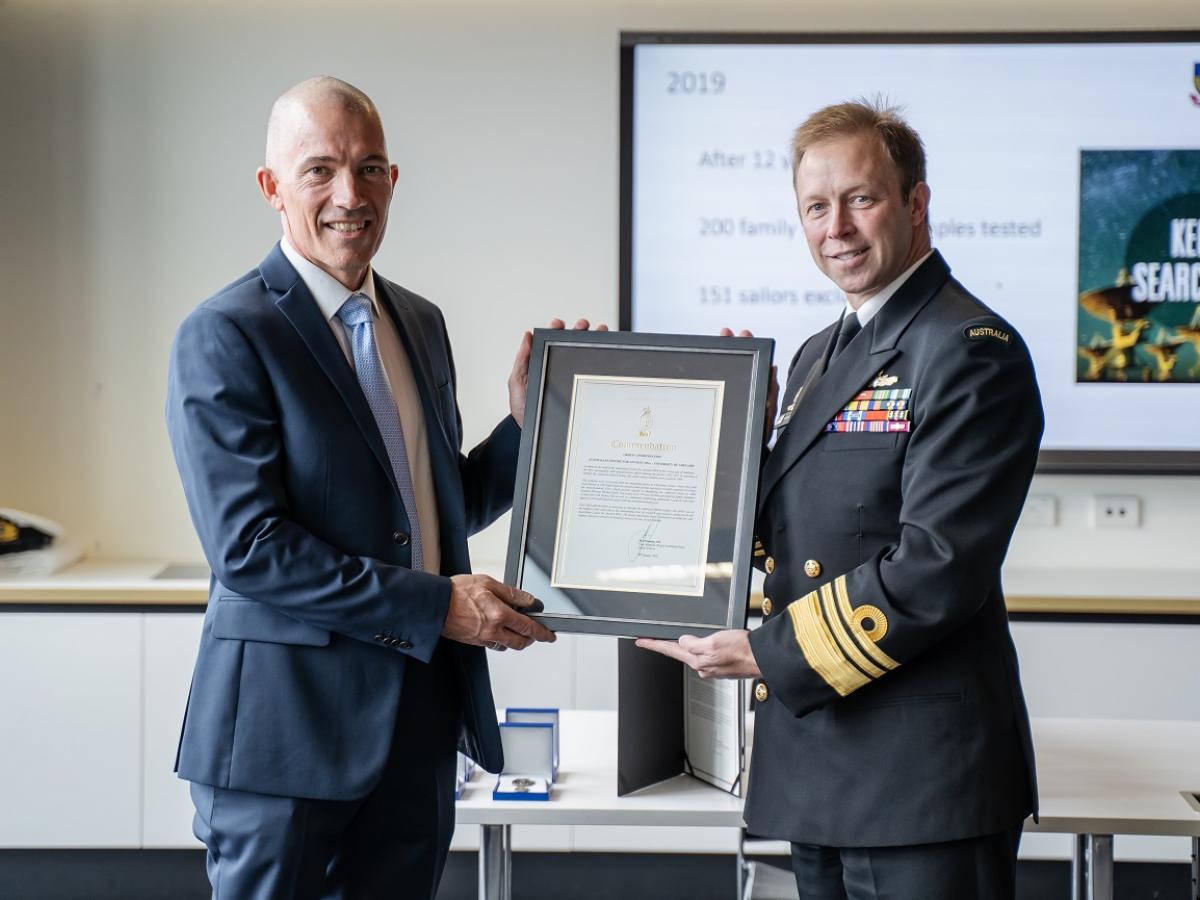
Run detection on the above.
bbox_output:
[0,612,204,847]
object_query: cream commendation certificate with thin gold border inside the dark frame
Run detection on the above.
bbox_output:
[551,374,725,596]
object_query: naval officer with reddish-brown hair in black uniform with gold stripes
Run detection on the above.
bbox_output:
[640,102,1043,900]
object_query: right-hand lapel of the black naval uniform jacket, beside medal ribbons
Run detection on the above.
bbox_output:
[758,251,950,510]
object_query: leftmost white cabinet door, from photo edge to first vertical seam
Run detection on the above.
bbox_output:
[0,612,143,847]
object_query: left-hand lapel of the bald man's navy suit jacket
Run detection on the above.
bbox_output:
[259,245,398,492]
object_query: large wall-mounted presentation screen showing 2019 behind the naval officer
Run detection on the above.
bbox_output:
[620,31,1200,473]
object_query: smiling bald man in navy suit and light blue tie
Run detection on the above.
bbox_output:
[167,77,587,900]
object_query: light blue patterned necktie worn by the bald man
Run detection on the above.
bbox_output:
[337,294,424,578]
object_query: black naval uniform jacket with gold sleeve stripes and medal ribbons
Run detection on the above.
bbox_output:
[745,252,1043,847]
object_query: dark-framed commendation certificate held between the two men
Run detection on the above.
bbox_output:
[505,329,773,637]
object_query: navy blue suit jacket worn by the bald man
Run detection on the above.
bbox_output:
[167,245,520,799]
